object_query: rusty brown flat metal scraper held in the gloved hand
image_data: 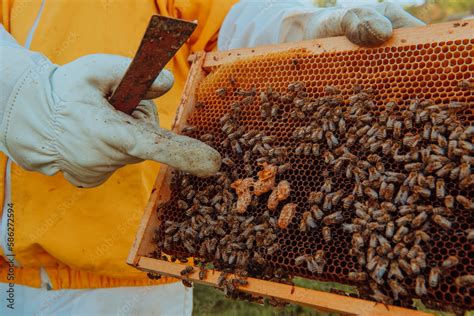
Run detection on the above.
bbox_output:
[109,15,197,114]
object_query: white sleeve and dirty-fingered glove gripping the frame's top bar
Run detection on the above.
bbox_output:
[218,0,424,50]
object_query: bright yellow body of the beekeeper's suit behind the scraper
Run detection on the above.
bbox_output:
[0,0,237,289]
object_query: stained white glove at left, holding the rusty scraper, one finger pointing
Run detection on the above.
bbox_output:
[0,30,220,187]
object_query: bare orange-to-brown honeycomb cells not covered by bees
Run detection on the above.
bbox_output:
[157,39,474,310]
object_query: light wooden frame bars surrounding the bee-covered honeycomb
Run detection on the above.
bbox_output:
[127,20,474,315]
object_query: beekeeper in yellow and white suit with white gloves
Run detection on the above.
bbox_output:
[0,0,422,315]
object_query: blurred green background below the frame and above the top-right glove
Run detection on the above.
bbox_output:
[193,0,474,316]
